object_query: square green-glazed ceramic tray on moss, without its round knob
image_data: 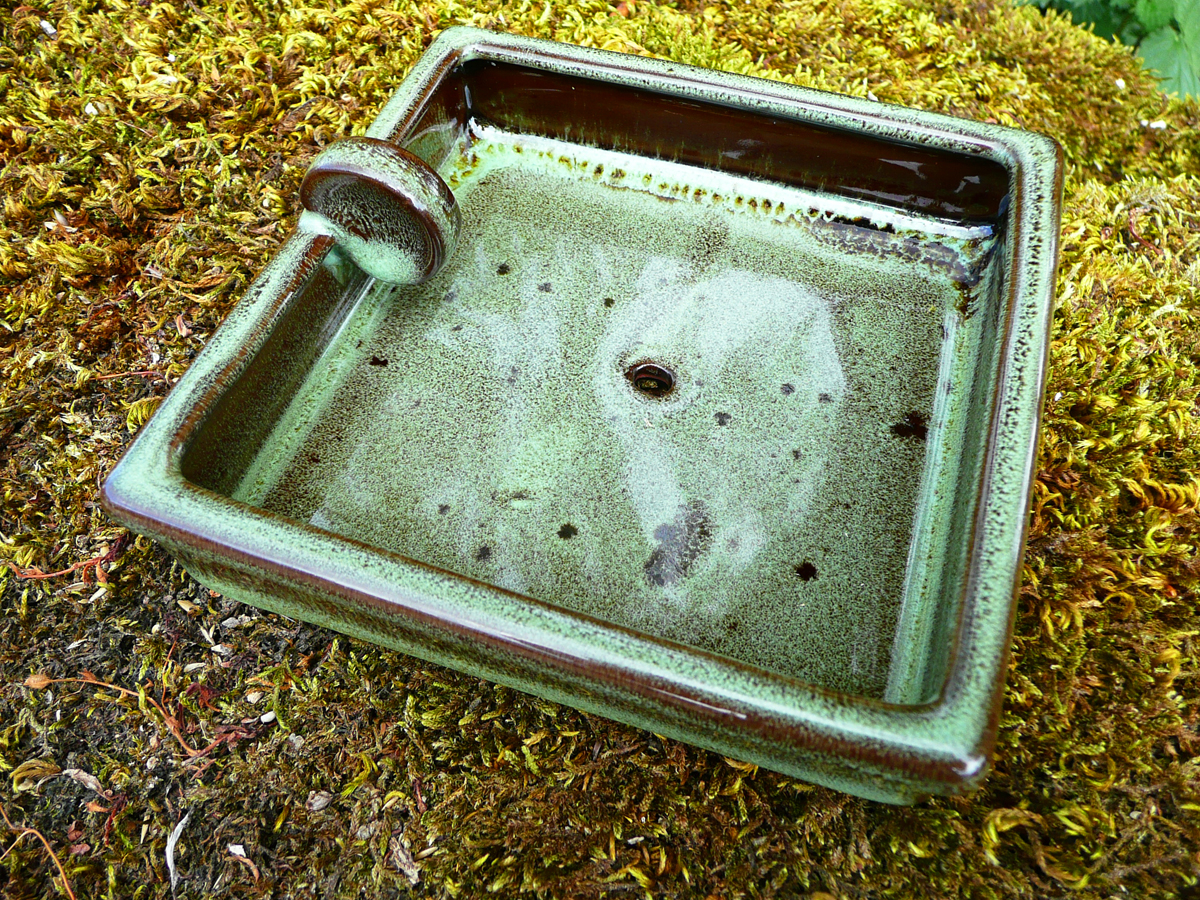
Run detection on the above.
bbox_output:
[104,29,1061,803]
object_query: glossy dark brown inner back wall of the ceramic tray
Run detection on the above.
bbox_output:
[451,60,1009,223]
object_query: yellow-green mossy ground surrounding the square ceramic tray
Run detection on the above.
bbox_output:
[0,0,1200,900]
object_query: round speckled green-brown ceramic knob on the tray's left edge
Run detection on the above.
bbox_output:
[300,138,461,284]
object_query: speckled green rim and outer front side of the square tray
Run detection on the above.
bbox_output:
[102,28,1062,802]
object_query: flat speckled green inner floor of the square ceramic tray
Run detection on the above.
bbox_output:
[235,134,993,697]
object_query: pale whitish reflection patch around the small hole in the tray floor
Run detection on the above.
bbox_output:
[592,257,846,640]
